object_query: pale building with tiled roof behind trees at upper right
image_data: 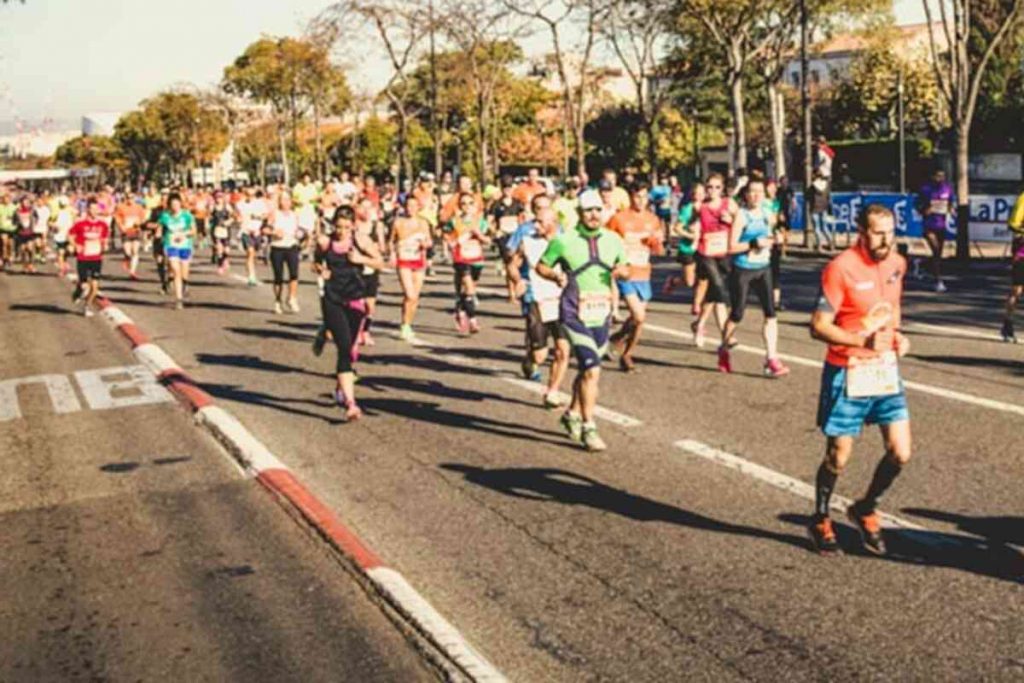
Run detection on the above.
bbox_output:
[785,22,948,88]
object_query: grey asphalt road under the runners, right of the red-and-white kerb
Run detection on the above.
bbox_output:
[4,246,1024,681]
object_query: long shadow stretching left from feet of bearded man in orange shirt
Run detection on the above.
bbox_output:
[440,463,807,548]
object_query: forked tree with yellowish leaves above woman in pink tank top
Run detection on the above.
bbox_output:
[680,0,799,168]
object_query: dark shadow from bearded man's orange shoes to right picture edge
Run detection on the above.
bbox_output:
[778,513,1024,584]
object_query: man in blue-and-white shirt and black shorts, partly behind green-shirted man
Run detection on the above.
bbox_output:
[510,208,570,410]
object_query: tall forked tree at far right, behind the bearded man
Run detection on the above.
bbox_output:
[923,0,1024,261]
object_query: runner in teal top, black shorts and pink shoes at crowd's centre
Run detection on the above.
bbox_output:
[444,193,490,334]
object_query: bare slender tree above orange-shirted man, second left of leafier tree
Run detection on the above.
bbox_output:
[602,0,676,174]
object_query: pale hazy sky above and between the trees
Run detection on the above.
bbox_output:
[0,0,924,133]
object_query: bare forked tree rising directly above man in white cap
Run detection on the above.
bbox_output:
[503,0,611,179]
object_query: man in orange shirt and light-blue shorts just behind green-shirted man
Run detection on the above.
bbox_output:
[608,182,665,373]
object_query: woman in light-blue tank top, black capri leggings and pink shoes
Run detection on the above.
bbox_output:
[718,177,790,377]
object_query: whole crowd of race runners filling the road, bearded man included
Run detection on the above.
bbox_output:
[0,169,1024,553]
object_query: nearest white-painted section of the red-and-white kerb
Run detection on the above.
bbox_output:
[367,566,508,683]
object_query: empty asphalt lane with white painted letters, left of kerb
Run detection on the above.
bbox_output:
[0,275,437,681]
